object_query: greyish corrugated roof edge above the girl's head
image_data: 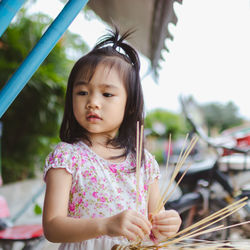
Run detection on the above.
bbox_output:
[88,0,182,78]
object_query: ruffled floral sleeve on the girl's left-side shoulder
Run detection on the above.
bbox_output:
[43,142,77,181]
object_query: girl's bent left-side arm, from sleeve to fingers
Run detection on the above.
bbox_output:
[43,169,150,242]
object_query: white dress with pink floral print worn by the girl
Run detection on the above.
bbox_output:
[44,141,160,250]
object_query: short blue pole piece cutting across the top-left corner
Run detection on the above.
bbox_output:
[0,0,25,37]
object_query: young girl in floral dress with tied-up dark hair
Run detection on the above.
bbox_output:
[43,29,181,250]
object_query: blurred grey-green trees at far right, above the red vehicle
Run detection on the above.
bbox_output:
[201,102,243,132]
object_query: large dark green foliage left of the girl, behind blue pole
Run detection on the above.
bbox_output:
[0,10,86,183]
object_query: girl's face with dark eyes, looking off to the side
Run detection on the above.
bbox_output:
[73,64,127,138]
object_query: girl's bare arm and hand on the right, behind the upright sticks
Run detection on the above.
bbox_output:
[148,179,181,240]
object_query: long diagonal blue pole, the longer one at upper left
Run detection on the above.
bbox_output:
[0,0,88,118]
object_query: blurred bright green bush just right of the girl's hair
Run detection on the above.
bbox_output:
[145,109,186,139]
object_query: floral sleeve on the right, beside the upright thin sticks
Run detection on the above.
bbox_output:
[144,150,161,185]
